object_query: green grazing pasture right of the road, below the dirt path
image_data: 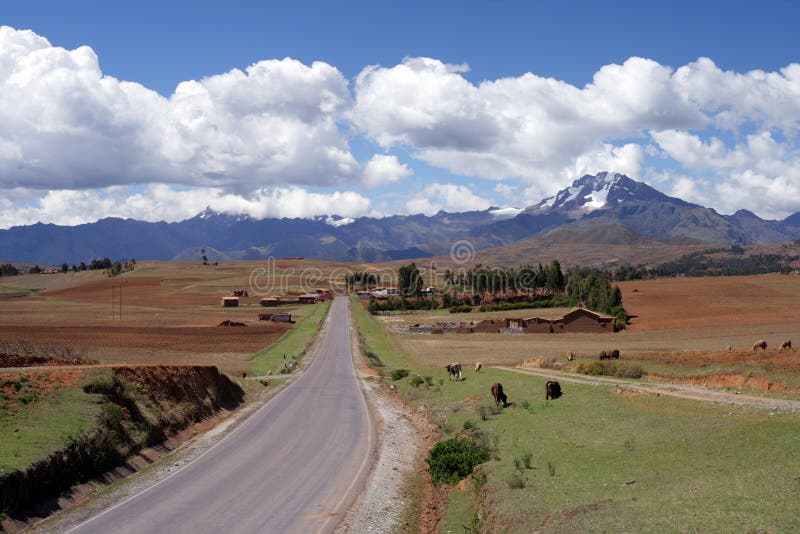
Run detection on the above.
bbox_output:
[355,309,800,532]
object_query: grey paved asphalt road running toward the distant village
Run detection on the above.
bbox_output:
[71,297,375,534]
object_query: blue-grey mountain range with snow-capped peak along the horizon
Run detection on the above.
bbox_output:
[0,172,800,264]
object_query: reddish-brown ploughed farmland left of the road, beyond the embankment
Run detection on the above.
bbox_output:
[0,260,336,374]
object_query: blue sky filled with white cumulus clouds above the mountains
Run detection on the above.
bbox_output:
[0,1,800,227]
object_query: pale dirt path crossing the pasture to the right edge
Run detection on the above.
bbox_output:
[494,365,800,413]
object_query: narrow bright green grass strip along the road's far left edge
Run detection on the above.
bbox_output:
[249,302,330,375]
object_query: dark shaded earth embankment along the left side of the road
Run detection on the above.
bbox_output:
[0,366,244,516]
